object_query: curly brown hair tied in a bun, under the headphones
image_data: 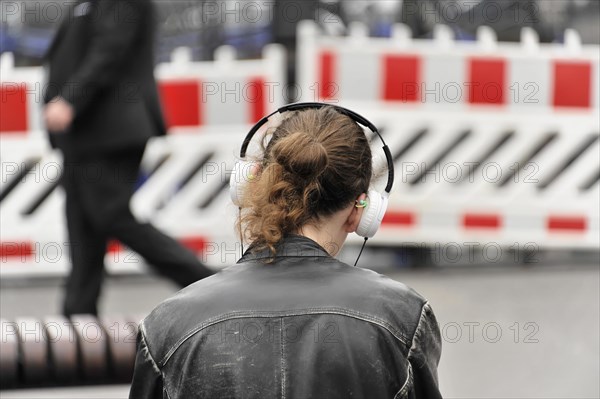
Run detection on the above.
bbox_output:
[238,107,372,255]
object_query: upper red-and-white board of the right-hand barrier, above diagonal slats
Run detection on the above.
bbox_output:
[297,21,600,113]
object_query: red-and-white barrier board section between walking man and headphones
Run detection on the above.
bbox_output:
[156,44,286,128]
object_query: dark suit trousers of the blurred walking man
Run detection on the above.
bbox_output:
[62,146,212,316]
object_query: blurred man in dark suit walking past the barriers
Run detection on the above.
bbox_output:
[44,0,212,316]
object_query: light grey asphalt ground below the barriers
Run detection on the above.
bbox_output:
[0,261,600,399]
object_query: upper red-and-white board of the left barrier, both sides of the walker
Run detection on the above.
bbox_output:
[0,44,286,135]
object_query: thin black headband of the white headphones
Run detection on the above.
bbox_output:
[240,102,394,194]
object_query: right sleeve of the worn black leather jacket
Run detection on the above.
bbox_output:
[408,303,442,399]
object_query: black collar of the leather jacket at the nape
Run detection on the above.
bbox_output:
[238,234,331,263]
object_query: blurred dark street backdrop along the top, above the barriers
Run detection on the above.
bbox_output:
[1,0,600,66]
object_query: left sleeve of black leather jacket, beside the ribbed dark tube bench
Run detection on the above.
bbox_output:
[129,324,163,399]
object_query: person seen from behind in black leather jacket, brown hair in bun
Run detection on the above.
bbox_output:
[130,106,441,399]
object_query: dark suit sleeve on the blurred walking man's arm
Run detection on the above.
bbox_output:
[60,0,146,114]
